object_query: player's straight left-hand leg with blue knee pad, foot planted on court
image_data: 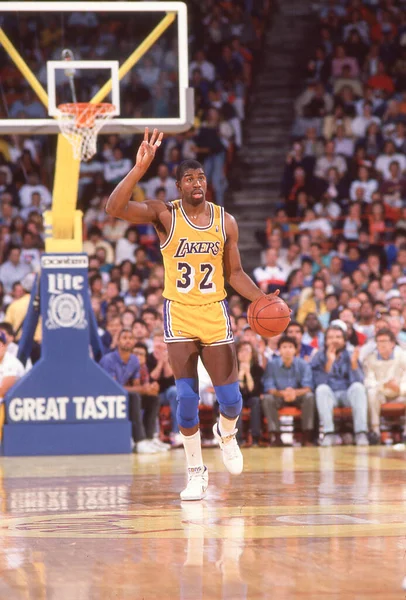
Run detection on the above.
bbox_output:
[168,341,208,500]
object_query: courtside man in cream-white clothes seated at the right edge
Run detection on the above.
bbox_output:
[364,328,406,444]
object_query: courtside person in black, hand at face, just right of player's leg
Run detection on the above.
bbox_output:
[236,342,264,446]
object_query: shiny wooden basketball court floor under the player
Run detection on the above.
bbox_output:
[0,447,406,600]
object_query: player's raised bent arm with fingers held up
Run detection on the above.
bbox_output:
[106,127,165,224]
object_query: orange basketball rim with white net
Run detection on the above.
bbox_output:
[56,102,116,161]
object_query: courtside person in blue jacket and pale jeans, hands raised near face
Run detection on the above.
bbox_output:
[311,325,368,446]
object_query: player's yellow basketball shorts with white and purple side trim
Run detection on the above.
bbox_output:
[164,299,234,346]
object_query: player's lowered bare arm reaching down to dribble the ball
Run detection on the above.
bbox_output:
[224,213,265,302]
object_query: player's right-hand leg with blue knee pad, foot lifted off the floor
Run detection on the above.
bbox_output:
[202,343,243,475]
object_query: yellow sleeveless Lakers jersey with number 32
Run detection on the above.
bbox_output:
[161,200,226,306]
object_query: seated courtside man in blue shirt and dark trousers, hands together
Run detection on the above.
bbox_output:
[262,336,315,446]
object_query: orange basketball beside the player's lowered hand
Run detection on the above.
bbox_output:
[247,296,290,337]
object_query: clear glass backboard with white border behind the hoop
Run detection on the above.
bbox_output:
[0,1,194,135]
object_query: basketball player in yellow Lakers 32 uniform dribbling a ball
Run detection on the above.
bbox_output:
[106,128,279,500]
